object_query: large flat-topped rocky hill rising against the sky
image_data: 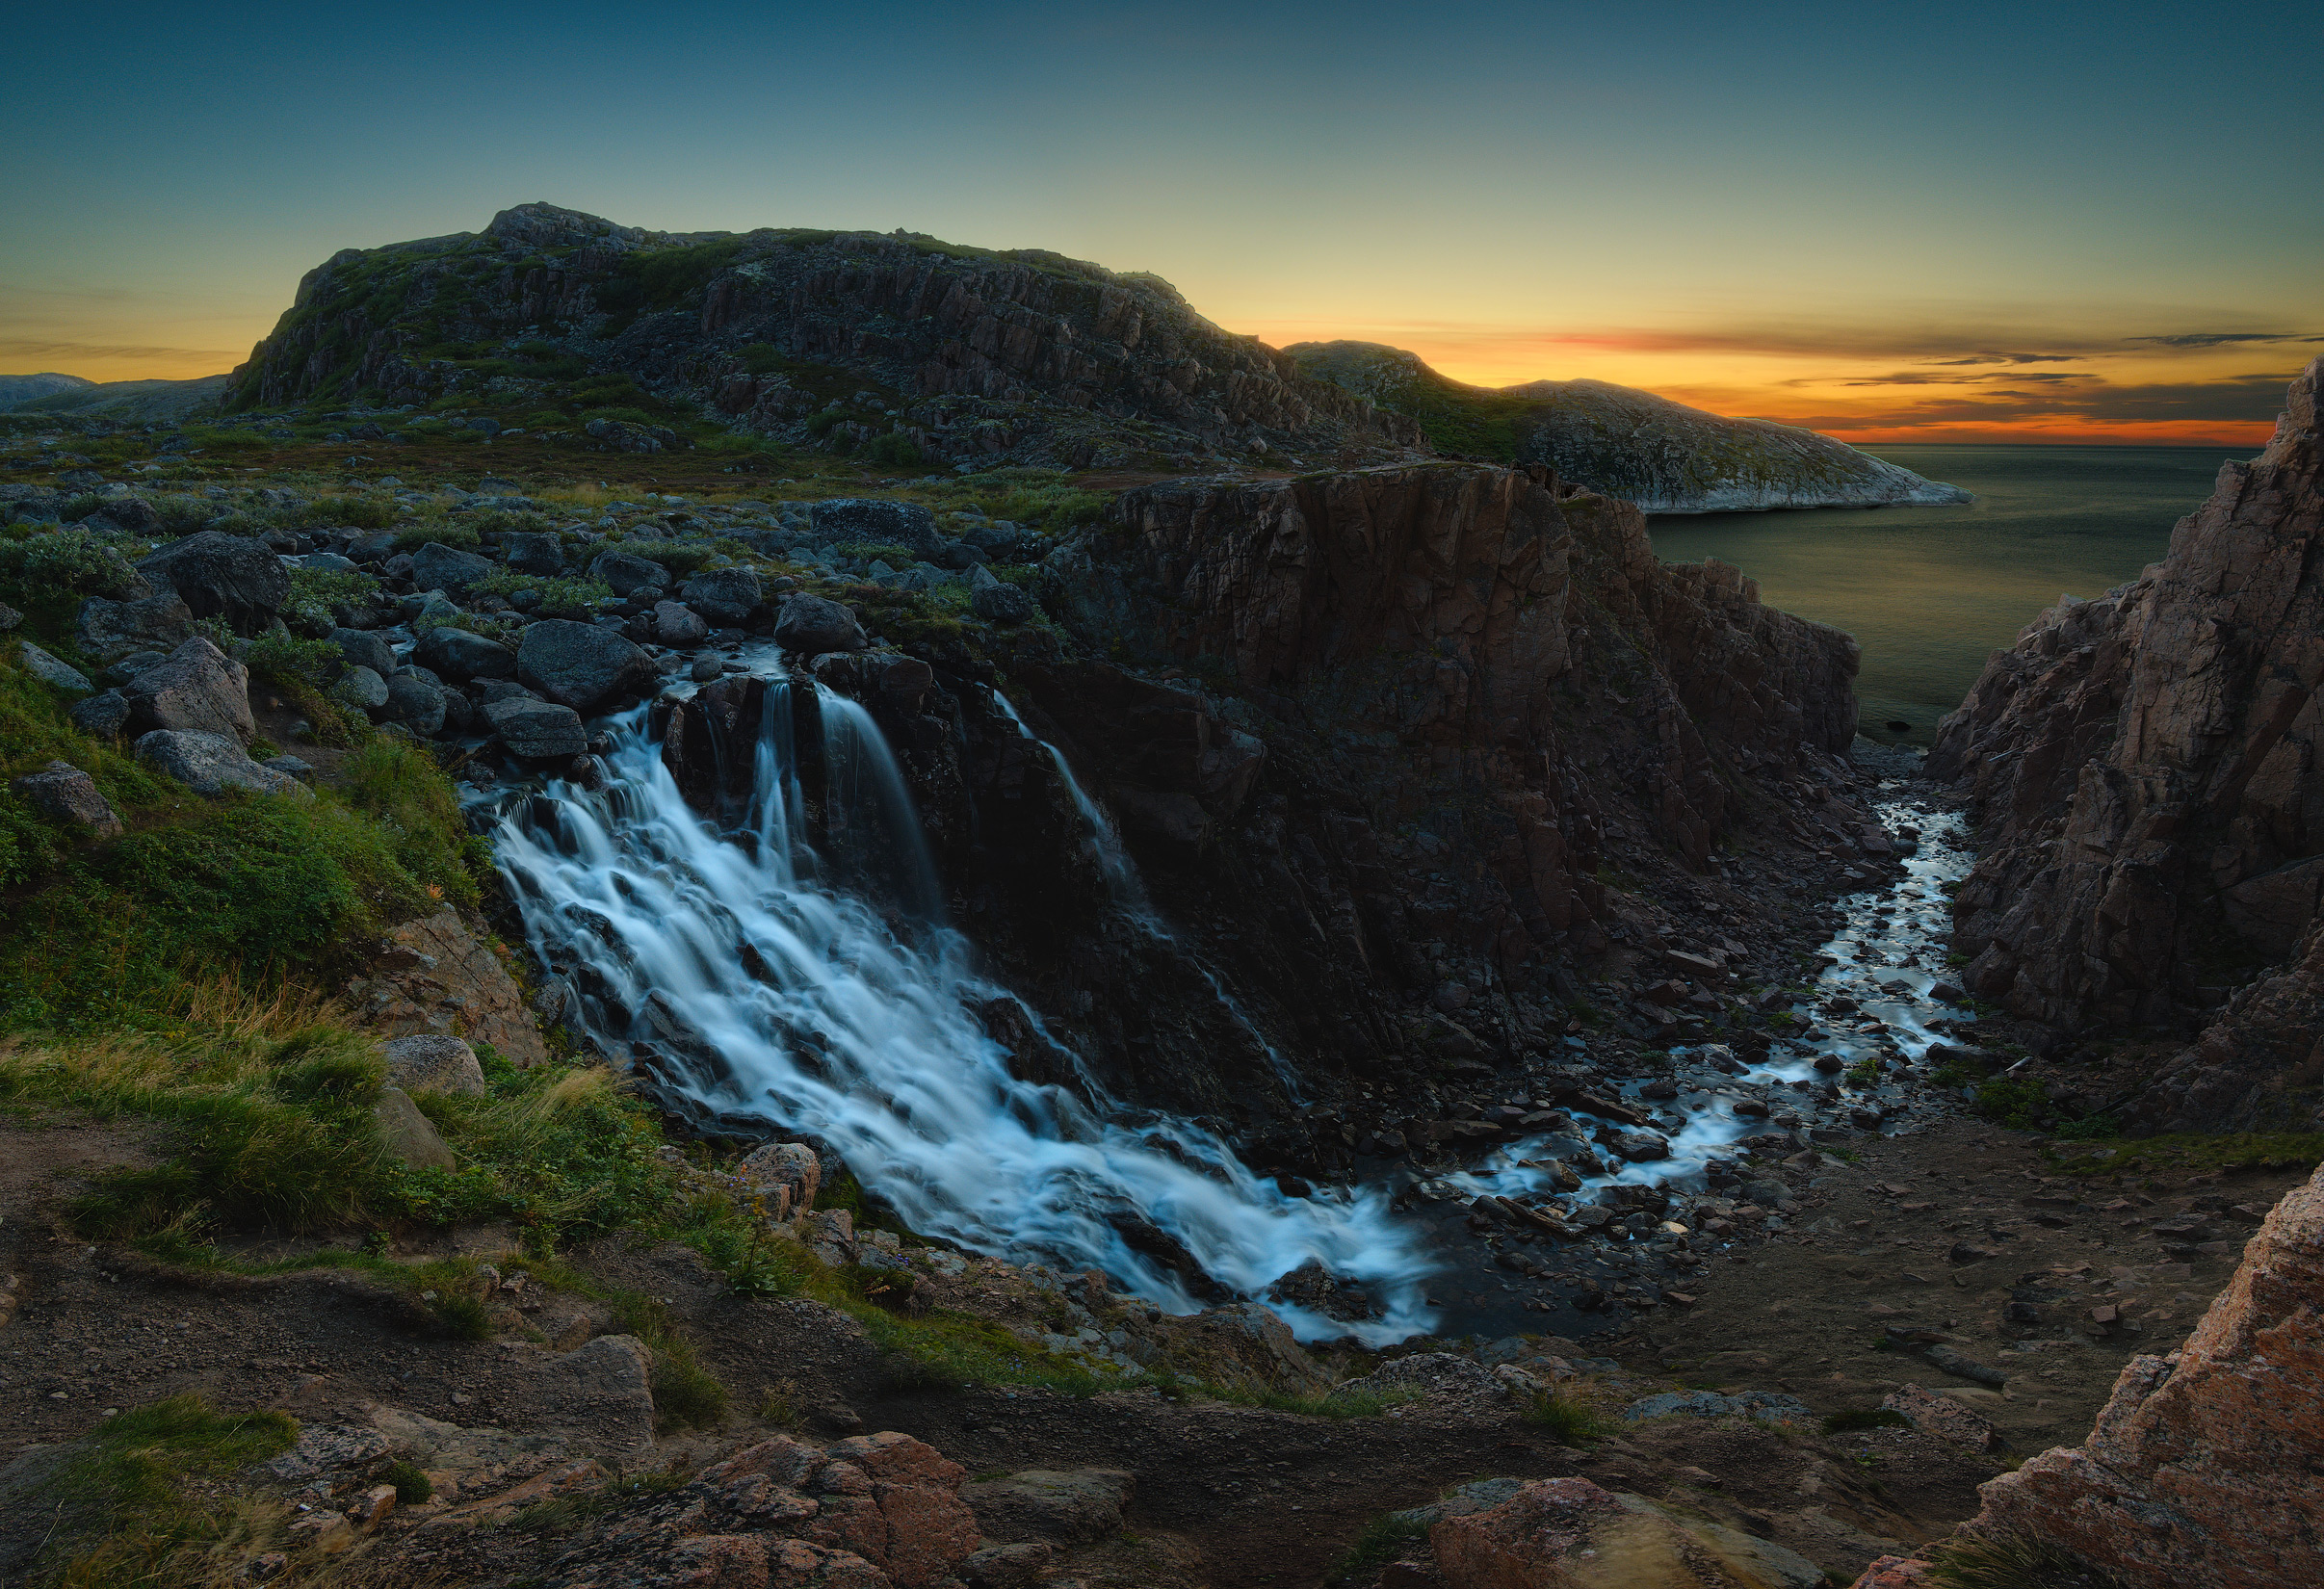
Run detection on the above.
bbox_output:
[237,204,1424,464]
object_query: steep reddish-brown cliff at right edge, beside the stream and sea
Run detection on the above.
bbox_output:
[1929,365,2324,1127]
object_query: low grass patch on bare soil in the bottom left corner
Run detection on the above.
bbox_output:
[28,1396,300,1589]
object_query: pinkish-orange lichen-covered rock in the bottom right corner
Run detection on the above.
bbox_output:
[1966,1152,2324,1589]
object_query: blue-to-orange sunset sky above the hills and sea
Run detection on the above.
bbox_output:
[0,0,2324,446]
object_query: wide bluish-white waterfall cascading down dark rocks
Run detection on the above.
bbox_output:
[495,678,1431,1342]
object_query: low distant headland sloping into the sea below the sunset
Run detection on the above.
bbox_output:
[1285,342,1969,513]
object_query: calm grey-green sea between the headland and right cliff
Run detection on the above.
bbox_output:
[1653,446,2255,745]
